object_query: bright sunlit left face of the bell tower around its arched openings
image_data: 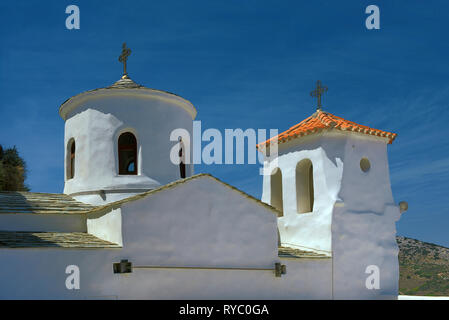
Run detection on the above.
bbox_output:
[262,133,346,254]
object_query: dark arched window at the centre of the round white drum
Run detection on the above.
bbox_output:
[118,132,137,175]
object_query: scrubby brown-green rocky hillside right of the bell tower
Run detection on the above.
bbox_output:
[397,237,449,296]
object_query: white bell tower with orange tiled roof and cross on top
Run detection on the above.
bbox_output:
[259,82,400,299]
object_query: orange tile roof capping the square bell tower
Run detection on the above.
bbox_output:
[257,110,397,148]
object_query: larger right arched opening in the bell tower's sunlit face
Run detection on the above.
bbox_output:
[296,159,315,213]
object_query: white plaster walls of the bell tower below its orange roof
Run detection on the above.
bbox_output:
[262,132,400,299]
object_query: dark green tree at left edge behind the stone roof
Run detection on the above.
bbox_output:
[0,145,29,191]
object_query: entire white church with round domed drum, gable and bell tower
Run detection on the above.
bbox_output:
[0,46,403,299]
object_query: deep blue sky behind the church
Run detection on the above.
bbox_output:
[0,0,449,247]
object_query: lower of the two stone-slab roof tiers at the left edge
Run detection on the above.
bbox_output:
[0,231,121,249]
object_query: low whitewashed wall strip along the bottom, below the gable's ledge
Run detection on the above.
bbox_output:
[0,249,332,299]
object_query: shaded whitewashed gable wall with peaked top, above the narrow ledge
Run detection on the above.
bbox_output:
[114,176,277,267]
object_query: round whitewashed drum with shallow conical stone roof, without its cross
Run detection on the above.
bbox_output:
[59,69,197,204]
